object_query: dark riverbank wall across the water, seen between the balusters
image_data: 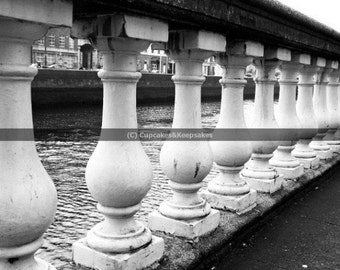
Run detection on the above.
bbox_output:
[32,69,278,108]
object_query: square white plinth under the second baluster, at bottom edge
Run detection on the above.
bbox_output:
[72,235,164,270]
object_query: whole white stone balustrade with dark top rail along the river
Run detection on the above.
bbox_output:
[0,0,340,270]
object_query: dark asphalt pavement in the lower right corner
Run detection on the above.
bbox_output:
[209,159,340,270]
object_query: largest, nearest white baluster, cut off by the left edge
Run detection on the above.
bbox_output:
[0,0,72,270]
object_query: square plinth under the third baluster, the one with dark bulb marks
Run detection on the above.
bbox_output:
[148,209,220,239]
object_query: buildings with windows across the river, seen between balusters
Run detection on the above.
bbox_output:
[32,29,222,76]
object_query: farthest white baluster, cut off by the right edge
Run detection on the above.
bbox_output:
[324,61,340,153]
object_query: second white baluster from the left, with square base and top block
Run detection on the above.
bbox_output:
[73,14,168,270]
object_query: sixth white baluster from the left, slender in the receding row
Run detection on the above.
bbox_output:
[269,50,304,179]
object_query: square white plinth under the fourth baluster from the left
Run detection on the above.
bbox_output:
[201,189,257,215]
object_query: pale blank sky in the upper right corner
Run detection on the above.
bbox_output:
[278,0,340,33]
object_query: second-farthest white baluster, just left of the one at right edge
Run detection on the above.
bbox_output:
[309,58,333,160]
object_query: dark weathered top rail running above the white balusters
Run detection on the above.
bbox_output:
[73,0,340,59]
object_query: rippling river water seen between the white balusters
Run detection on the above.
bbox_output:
[34,102,252,270]
